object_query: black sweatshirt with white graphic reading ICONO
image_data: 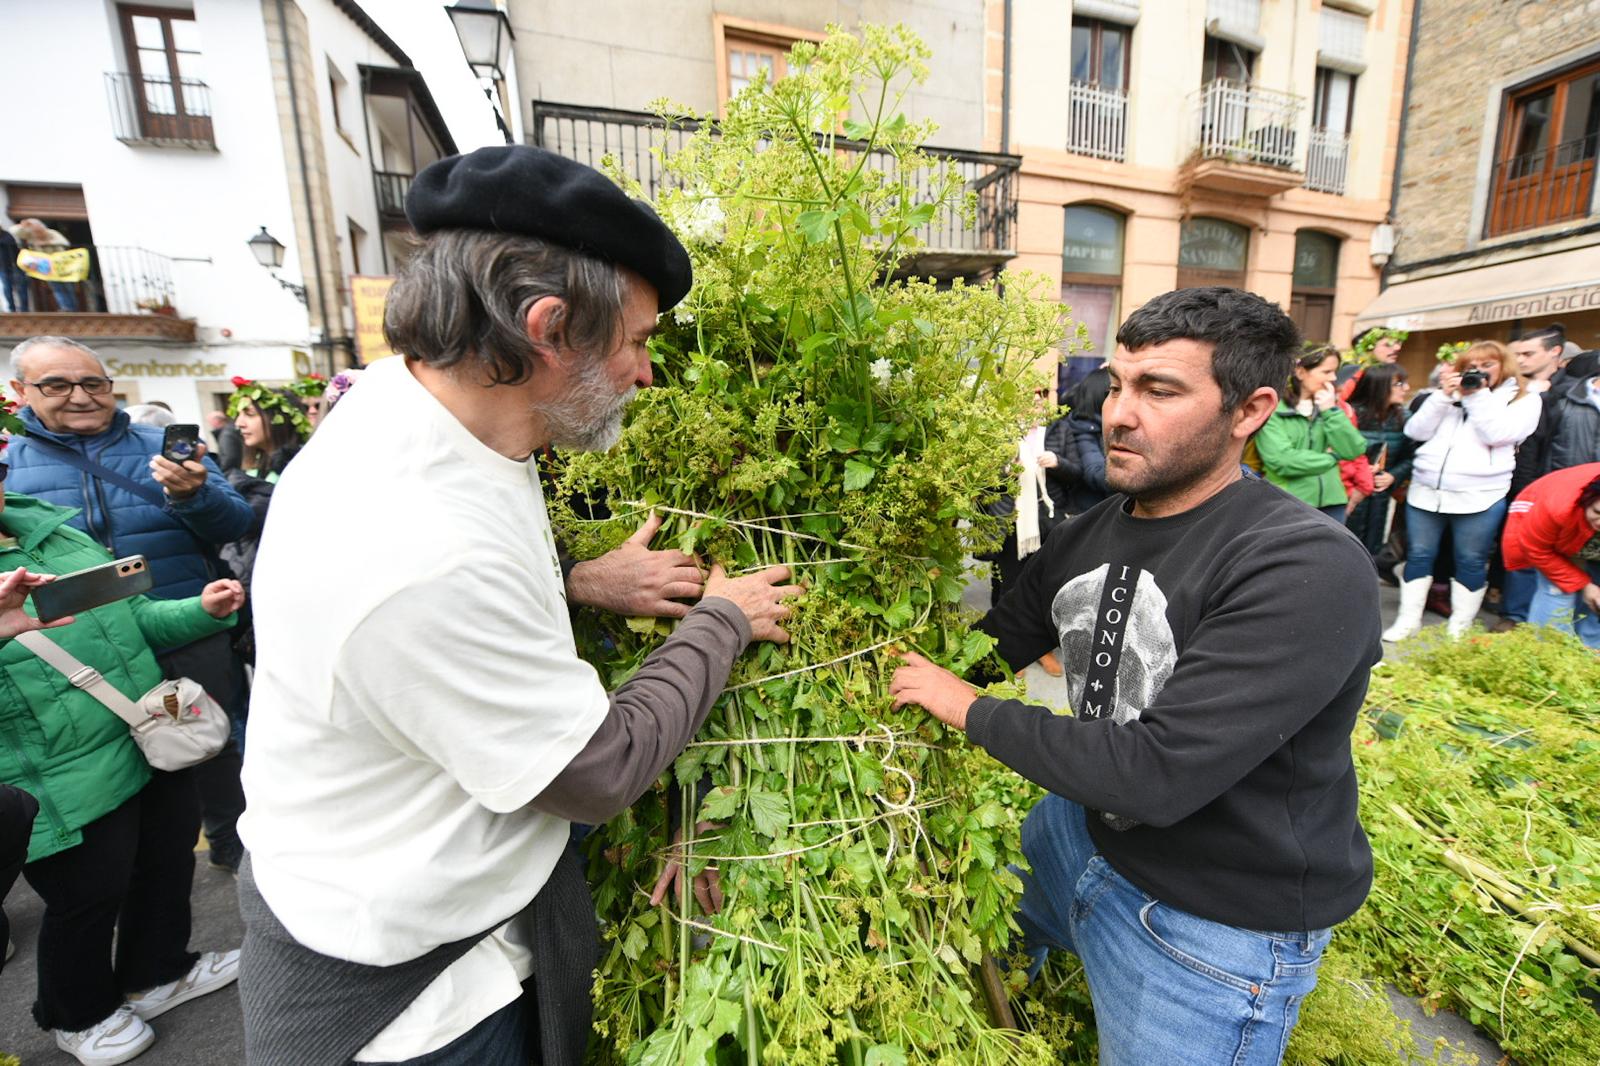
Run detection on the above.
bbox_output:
[966,479,1382,932]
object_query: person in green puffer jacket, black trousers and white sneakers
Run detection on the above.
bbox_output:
[0,480,243,1063]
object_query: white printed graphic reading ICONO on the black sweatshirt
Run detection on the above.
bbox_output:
[1050,563,1178,725]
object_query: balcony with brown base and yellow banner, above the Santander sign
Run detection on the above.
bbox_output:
[0,245,195,343]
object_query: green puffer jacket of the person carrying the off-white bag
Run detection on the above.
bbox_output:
[0,493,234,863]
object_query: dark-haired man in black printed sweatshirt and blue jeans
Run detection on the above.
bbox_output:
[891,288,1381,1066]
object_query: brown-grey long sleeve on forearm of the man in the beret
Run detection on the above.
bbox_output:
[533,597,750,826]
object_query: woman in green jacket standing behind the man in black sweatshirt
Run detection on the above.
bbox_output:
[1256,349,1366,525]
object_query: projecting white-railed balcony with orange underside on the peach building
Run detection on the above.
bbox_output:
[1189,78,1306,197]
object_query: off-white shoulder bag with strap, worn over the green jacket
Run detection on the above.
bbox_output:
[16,631,230,770]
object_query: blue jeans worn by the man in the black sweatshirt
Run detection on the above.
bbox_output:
[1018,794,1331,1066]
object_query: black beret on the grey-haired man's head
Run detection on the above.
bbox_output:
[405,144,694,311]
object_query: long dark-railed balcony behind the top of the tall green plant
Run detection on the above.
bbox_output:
[531,101,1022,279]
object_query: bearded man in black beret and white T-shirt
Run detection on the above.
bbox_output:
[240,146,795,1066]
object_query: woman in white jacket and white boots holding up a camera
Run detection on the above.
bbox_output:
[1384,341,1542,642]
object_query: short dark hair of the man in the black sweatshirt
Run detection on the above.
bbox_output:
[1117,285,1301,411]
